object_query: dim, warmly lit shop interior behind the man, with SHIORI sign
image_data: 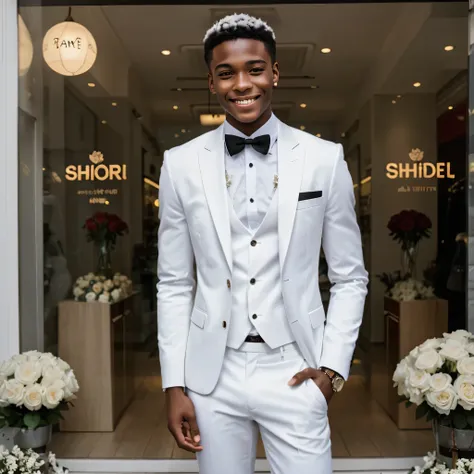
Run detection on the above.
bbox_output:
[19,2,468,459]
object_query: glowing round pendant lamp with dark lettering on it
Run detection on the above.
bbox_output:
[43,8,97,76]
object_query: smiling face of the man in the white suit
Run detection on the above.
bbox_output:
[209,38,279,128]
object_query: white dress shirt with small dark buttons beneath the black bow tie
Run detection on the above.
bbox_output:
[224,114,278,230]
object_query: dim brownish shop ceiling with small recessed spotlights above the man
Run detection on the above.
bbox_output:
[97,2,467,133]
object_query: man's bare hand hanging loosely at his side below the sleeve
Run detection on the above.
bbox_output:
[166,387,202,453]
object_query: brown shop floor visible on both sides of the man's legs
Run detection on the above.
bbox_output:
[51,344,434,459]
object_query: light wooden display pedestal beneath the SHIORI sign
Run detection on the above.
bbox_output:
[58,293,137,432]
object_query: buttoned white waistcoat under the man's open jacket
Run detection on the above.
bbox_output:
[227,190,294,349]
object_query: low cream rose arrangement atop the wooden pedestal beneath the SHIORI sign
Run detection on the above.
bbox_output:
[72,272,133,303]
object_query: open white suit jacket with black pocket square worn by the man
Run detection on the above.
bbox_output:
[157,121,368,394]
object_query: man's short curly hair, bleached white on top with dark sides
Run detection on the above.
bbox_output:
[204,14,276,66]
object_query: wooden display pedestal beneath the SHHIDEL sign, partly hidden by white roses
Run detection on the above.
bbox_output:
[384,297,448,429]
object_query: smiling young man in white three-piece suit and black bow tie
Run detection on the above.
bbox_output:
[158,14,367,474]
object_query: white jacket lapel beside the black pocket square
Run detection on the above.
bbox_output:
[277,121,304,270]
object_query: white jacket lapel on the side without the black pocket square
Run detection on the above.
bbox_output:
[199,125,232,270]
